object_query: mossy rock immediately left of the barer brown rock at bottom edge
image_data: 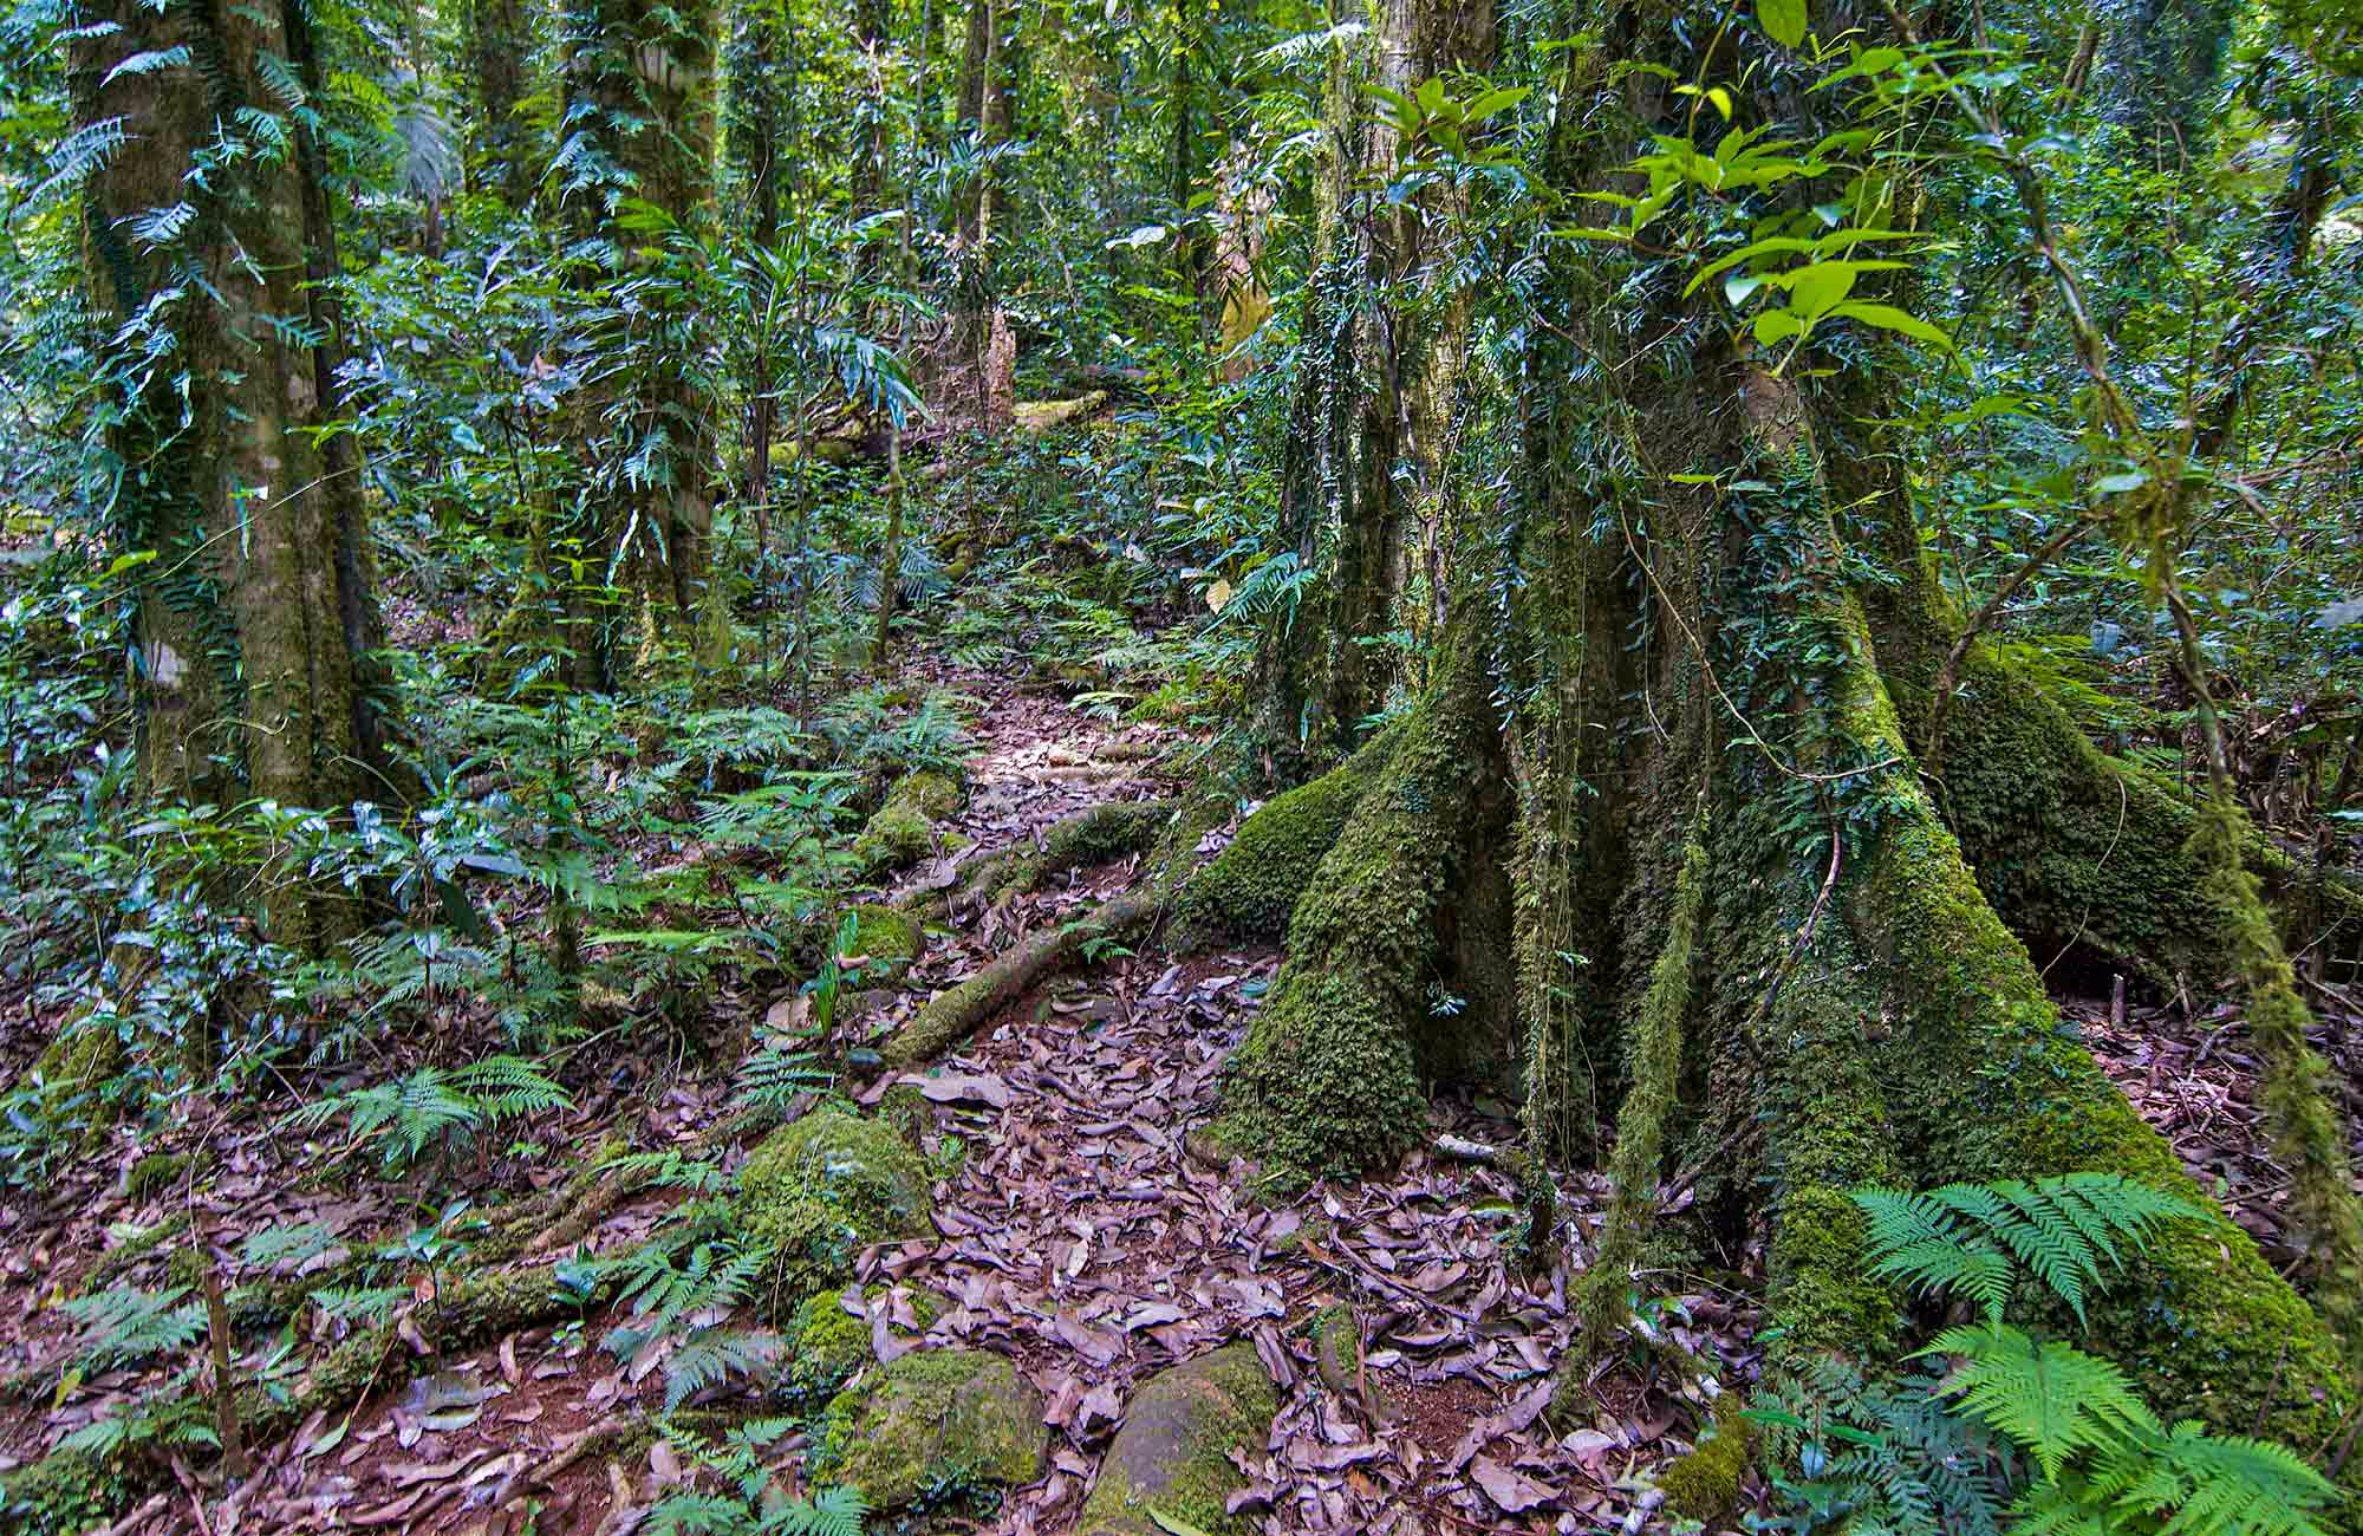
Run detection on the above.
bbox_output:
[815,1349,1049,1510]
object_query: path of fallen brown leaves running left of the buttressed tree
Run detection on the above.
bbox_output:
[846,675,1753,1531]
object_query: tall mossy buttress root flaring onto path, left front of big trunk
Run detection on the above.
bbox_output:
[1217,647,1496,1177]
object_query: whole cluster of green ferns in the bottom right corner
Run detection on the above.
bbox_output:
[1749,1174,2337,1536]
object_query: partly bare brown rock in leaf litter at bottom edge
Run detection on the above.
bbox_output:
[1075,1342,1278,1536]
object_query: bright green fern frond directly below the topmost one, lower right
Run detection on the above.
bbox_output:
[1921,1326,2160,1482]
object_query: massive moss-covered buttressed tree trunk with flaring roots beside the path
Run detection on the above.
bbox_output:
[1209,9,2351,1446]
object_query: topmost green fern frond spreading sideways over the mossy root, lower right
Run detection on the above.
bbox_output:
[1855,1172,2202,1323]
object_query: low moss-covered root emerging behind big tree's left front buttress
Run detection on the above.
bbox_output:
[1177,733,1397,938]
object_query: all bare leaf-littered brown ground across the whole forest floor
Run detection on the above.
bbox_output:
[0,652,2351,1536]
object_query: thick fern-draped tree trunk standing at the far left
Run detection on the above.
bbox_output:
[71,0,383,950]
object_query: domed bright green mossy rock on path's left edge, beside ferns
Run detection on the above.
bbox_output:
[737,1108,933,1314]
